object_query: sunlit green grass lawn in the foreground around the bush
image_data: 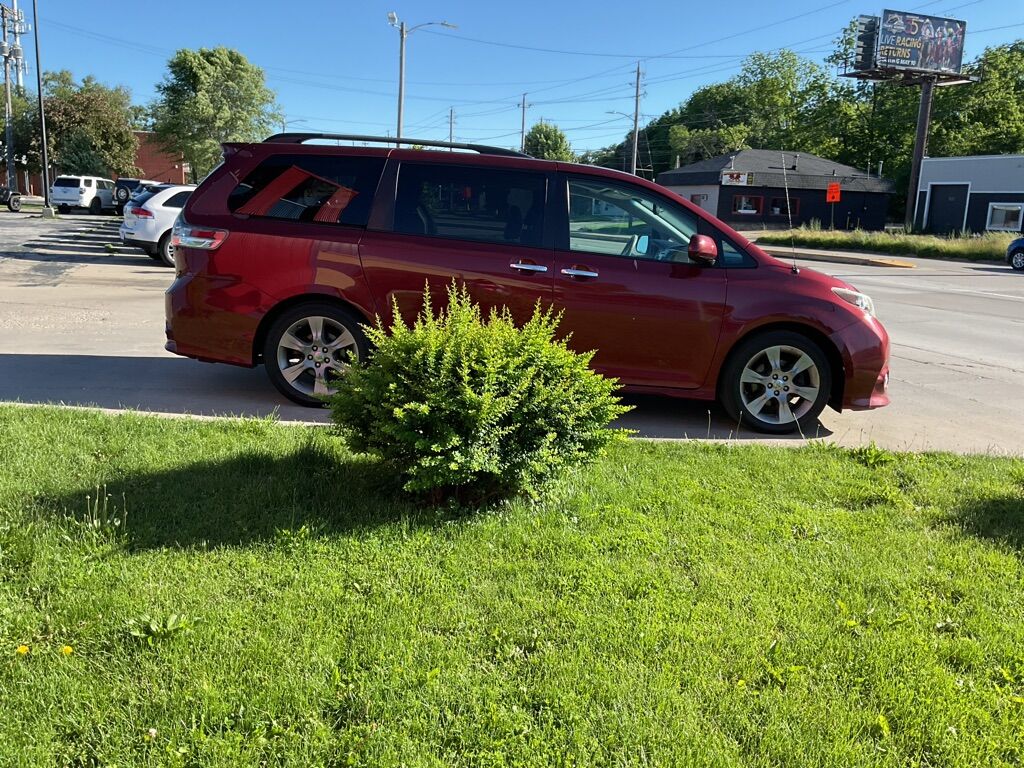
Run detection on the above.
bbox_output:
[0,407,1024,768]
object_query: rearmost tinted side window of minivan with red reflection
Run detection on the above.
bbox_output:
[227,155,384,226]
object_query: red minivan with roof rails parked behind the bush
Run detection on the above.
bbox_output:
[166,133,889,432]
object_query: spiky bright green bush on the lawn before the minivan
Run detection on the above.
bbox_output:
[331,283,629,502]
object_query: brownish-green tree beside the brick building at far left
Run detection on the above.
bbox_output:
[33,71,138,176]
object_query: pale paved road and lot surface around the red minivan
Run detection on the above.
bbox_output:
[0,213,1024,455]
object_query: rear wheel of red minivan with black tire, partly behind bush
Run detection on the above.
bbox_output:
[262,301,369,407]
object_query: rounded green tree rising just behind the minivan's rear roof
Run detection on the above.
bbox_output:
[152,47,281,178]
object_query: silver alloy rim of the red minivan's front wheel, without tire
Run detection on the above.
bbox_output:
[739,345,821,425]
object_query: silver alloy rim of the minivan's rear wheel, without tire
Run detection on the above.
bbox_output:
[278,315,359,395]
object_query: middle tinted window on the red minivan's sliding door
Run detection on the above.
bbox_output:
[394,163,548,247]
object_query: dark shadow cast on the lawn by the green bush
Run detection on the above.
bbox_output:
[48,445,428,550]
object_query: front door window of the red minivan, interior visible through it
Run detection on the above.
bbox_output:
[568,177,697,263]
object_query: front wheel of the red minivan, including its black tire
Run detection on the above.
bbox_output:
[719,331,833,434]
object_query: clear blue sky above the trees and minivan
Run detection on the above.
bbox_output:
[32,0,1024,152]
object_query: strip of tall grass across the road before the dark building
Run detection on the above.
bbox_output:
[758,228,1021,261]
